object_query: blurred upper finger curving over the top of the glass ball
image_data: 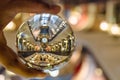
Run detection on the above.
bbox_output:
[0,0,61,31]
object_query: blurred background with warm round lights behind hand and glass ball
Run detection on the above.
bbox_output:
[0,0,120,80]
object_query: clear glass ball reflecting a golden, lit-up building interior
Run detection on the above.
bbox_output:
[16,13,75,71]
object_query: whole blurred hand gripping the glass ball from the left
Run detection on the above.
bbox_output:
[0,0,60,77]
